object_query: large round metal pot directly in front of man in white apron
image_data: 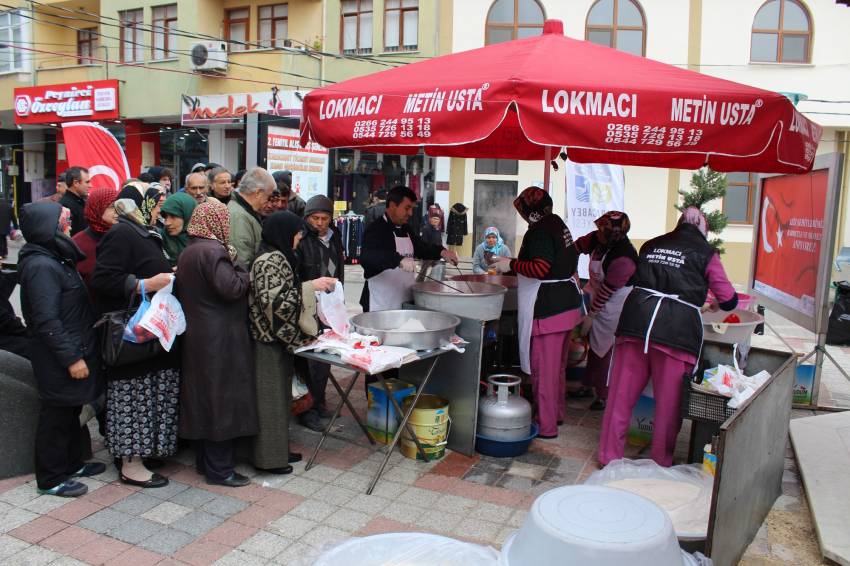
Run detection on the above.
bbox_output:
[413,281,508,321]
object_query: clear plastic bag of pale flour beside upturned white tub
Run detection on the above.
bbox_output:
[584,459,714,539]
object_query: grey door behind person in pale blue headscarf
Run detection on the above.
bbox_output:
[472,180,519,255]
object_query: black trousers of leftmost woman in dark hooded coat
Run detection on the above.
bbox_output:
[35,404,86,489]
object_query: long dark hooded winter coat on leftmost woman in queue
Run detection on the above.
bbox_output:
[18,203,101,407]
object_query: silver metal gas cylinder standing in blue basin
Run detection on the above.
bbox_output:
[478,374,531,441]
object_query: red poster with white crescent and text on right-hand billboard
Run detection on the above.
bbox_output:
[753,169,829,317]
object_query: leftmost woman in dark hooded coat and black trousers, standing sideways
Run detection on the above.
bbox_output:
[18,202,106,497]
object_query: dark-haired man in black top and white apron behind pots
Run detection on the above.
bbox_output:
[360,186,457,312]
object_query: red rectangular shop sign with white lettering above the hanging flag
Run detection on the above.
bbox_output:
[15,79,119,124]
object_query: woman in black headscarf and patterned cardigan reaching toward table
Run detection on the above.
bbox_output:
[249,211,337,474]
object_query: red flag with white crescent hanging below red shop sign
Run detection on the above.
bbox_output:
[62,122,130,191]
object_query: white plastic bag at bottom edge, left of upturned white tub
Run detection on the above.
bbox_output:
[295,533,499,566]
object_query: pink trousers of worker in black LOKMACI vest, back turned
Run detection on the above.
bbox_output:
[599,339,693,466]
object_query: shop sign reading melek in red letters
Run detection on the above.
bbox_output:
[180,88,306,126]
